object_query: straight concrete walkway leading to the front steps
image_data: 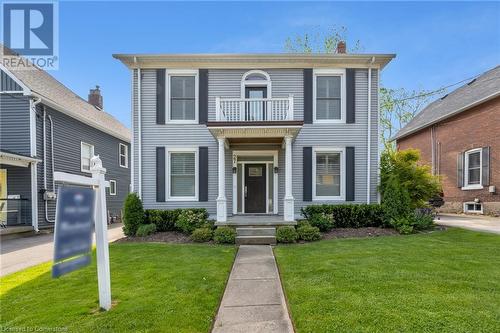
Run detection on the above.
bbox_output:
[212,245,293,333]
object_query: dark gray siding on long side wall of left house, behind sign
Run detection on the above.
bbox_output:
[37,106,130,223]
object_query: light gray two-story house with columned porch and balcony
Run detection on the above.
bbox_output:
[114,49,394,225]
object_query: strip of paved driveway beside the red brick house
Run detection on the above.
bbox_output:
[435,214,500,234]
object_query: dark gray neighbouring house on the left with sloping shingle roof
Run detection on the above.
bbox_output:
[0,48,131,231]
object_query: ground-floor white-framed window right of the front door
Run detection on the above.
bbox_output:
[313,149,345,200]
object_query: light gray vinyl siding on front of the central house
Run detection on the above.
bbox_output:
[132,69,378,217]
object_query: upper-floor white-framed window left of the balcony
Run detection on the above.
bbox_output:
[167,70,198,123]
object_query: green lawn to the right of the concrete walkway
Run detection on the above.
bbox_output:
[275,229,500,332]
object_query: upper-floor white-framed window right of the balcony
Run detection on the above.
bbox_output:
[313,69,345,123]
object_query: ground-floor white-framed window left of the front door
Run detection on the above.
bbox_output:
[168,148,198,200]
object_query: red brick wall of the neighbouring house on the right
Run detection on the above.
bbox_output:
[397,97,500,214]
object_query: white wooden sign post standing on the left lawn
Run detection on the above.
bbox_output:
[90,156,111,310]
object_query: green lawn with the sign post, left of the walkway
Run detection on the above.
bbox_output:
[0,243,235,332]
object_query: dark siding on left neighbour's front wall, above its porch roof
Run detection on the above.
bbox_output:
[0,94,30,156]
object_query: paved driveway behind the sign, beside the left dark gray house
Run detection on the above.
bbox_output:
[0,224,124,276]
